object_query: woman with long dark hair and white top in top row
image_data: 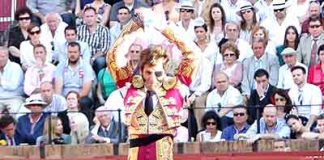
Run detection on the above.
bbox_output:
[208,3,226,43]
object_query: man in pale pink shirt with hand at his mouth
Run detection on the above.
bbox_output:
[24,44,56,96]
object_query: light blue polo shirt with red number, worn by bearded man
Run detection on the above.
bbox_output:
[55,60,95,96]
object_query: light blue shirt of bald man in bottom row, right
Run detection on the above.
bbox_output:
[246,117,290,139]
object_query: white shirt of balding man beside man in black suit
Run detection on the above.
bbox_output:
[206,85,243,118]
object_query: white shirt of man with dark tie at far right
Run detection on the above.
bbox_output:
[288,83,322,118]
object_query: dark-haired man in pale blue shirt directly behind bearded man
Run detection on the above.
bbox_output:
[53,26,91,63]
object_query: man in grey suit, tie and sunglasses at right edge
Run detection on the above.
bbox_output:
[297,17,324,68]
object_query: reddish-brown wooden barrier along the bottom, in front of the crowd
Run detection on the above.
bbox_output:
[0,140,324,160]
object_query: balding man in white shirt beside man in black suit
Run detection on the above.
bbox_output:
[206,72,243,128]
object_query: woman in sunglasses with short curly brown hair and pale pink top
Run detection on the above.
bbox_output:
[214,42,243,89]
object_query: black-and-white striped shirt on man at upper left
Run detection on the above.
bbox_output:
[77,24,110,55]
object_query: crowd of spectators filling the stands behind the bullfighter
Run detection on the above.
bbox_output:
[0,0,324,150]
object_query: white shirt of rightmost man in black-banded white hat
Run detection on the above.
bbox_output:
[261,14,301,46]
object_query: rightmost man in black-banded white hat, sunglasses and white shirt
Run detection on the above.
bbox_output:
[261,0,301,47]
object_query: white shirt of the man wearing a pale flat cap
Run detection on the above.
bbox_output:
[277,62,307,89]
